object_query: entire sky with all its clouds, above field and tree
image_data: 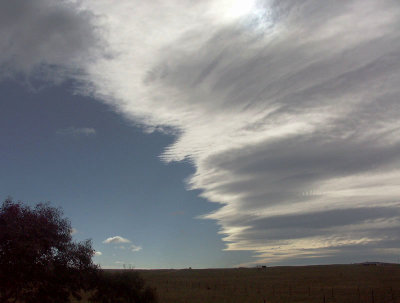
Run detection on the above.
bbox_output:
[0,0,400,268]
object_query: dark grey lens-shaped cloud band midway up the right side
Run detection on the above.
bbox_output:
[208,134,400,180]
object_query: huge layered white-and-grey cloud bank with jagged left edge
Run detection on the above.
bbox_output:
[0,0,400,263]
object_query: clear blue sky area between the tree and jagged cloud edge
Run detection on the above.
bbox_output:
[0,81,253,268]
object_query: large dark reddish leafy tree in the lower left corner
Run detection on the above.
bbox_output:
[0,199,98,303]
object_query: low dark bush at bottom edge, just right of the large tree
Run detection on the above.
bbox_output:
[91,270,157,303]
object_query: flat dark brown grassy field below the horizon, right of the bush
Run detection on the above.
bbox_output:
[140,265,400,303]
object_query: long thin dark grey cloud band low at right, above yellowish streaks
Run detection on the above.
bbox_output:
[223,214,400,245]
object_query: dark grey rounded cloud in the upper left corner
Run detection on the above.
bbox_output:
[0,0,101,80]
